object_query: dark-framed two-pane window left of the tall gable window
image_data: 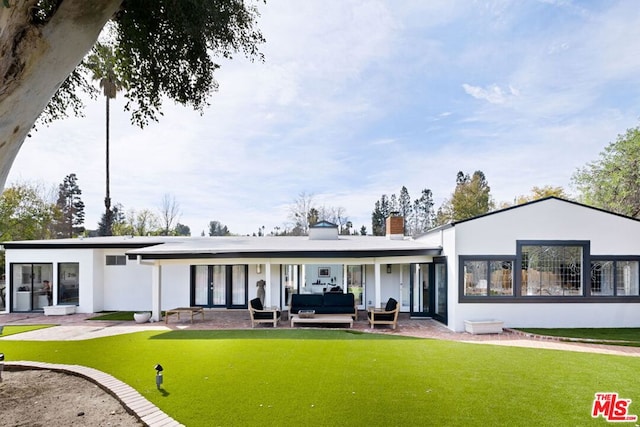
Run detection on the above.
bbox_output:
[463,259,513,296]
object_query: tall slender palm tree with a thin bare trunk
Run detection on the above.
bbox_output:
[87,43,125,236]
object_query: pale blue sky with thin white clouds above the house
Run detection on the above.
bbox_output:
[7,0,640,235]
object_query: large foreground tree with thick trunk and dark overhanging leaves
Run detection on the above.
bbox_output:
[0,0,264,188]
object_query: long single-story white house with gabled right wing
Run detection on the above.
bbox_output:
[0,197,640,331]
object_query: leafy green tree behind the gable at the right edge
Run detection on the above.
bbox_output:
[572,127,640,218]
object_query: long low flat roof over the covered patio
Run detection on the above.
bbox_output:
[4,236,441,259]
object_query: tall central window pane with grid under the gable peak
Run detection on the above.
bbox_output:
[520,245,583,296]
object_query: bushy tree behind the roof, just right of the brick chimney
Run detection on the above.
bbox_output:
[450,171,493,221]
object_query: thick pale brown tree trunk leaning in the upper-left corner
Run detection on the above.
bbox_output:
[0,0,122,190]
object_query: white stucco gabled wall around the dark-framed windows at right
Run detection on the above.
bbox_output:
[444,199,640,331]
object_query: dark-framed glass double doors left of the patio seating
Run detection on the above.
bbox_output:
[191,264,249,308]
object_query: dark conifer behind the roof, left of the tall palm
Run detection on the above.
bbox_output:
[54,173,84,239]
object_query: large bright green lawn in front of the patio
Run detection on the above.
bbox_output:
[0,329,640,426]
